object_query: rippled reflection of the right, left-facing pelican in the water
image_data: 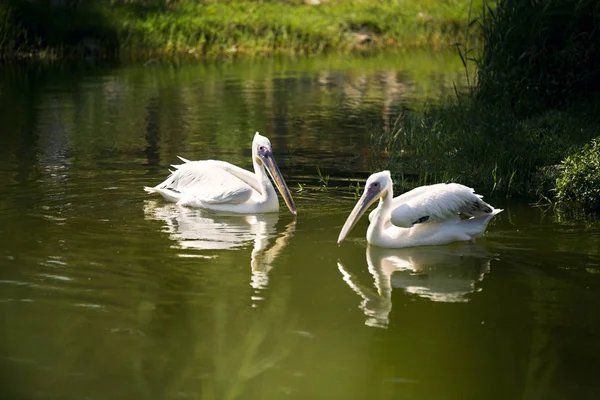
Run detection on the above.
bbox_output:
[338,244,493,328]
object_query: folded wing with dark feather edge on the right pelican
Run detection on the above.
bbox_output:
[390,183,494,228]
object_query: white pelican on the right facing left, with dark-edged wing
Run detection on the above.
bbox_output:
[337,171,502,249]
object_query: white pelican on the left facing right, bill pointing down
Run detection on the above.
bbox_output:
[144,132,296,215]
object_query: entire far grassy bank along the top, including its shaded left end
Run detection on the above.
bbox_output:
[0,0,482,59]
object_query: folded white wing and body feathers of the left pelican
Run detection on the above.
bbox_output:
[151,159,259,204]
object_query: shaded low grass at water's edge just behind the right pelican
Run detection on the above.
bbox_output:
[373,95,597,196]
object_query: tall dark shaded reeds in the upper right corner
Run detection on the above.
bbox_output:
[476,0,600,117]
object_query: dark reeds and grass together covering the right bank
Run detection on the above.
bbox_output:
[375,0,600,209]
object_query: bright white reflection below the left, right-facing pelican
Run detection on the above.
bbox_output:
[144,200,296,290]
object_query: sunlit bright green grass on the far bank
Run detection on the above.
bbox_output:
[120,0,480,56]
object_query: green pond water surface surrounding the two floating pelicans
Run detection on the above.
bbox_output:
[0,52,600,399]
